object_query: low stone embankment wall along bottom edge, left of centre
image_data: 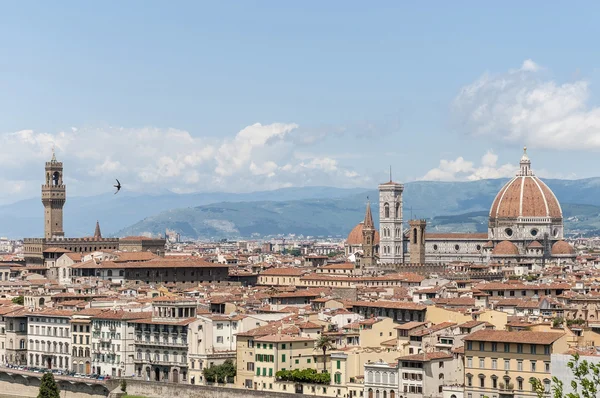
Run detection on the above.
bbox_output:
[108,379,324,398]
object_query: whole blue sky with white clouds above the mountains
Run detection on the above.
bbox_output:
[0,1,600,203]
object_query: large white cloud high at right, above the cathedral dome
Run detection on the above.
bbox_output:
[452,59,600,150]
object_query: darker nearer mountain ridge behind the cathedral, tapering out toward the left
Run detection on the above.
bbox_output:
[117,178,600,238]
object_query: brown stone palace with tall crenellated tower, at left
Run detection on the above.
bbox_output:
[23,152,166,265]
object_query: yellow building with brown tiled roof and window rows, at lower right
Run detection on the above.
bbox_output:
[464,330,568,398]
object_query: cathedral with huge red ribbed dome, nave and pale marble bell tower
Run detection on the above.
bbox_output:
[348,149,576,267]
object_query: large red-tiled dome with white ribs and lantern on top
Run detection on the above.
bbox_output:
[490,148,562,221]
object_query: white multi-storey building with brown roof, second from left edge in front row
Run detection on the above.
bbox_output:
[27,309,73,370]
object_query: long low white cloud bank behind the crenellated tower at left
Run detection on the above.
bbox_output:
[0,123,368,203]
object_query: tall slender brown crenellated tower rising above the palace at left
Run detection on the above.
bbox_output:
[42,149,67,239]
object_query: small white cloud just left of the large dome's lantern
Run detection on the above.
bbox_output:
[420,151,518,181]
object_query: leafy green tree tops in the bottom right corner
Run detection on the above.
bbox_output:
[529,354,600,398]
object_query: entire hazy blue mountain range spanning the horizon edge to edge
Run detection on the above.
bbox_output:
[0,178,600,239]
